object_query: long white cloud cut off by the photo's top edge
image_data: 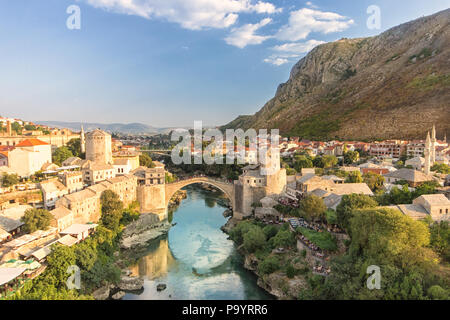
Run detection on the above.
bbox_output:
[84,0,281,30]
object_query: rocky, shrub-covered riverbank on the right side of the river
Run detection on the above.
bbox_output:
[221,218,347,300]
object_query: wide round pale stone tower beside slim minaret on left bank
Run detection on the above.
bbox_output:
[86,129,113,164]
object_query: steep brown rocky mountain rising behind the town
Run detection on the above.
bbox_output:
[222,9,450,140]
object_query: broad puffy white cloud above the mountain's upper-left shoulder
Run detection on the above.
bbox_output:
[276,8,354,41]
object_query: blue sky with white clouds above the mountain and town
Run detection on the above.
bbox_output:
[0,0,450,127]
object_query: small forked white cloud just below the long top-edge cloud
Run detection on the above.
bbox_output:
[225,18,272,49]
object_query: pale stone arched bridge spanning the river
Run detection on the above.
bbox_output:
[165,177,234,208]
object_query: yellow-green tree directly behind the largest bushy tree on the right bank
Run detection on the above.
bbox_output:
[336,193,378,231]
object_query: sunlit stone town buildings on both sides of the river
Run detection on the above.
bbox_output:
[0,118,450,297]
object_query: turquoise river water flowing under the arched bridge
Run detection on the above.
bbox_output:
[124,185,272,300]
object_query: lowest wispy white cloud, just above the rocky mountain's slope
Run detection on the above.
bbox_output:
[264,40,325,66]
